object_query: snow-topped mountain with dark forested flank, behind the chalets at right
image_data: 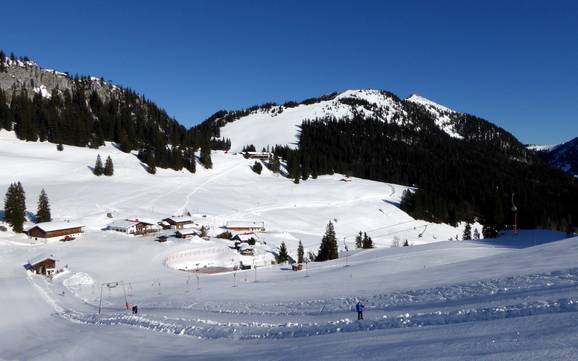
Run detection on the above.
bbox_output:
[199,90,578,232]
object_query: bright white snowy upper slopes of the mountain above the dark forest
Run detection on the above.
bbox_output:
[216,89,462,151]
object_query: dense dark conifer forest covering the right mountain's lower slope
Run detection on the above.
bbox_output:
[273,114,578,231]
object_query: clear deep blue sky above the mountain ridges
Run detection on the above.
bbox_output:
[0,0,578,143]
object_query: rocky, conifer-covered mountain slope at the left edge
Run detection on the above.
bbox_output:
[0,51,214,172]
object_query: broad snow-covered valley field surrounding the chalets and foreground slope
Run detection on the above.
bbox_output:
[0,132,578,360]
